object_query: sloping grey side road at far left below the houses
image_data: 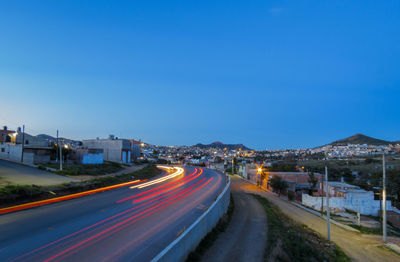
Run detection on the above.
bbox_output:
[0,160,76,186]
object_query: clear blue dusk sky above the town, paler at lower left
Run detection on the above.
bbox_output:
[0,0,400,149]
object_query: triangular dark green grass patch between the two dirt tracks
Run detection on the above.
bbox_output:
[253,195,351,262]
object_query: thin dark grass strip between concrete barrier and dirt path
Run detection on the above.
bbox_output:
[186,194,235,262]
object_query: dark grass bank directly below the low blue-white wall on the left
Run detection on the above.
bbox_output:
[39,161,124,176]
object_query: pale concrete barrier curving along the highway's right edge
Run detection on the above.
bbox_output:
[152,173,231,262]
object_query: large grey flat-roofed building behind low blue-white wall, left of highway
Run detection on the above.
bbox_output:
[82,135,132,163]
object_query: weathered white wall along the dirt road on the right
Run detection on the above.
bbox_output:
[301,194,392,216]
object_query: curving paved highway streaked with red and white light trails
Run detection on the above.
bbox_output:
[0,167,226,261]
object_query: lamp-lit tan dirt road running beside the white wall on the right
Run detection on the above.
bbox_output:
[232,177,400,262]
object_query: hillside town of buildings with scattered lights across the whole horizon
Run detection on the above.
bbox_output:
[0,126,400,221]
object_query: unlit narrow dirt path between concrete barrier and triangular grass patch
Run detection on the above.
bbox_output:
[202,179,267,262]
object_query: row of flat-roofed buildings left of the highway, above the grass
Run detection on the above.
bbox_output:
[0,126,142,165]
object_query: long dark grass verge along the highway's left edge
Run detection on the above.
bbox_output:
[0,165,162,207]
